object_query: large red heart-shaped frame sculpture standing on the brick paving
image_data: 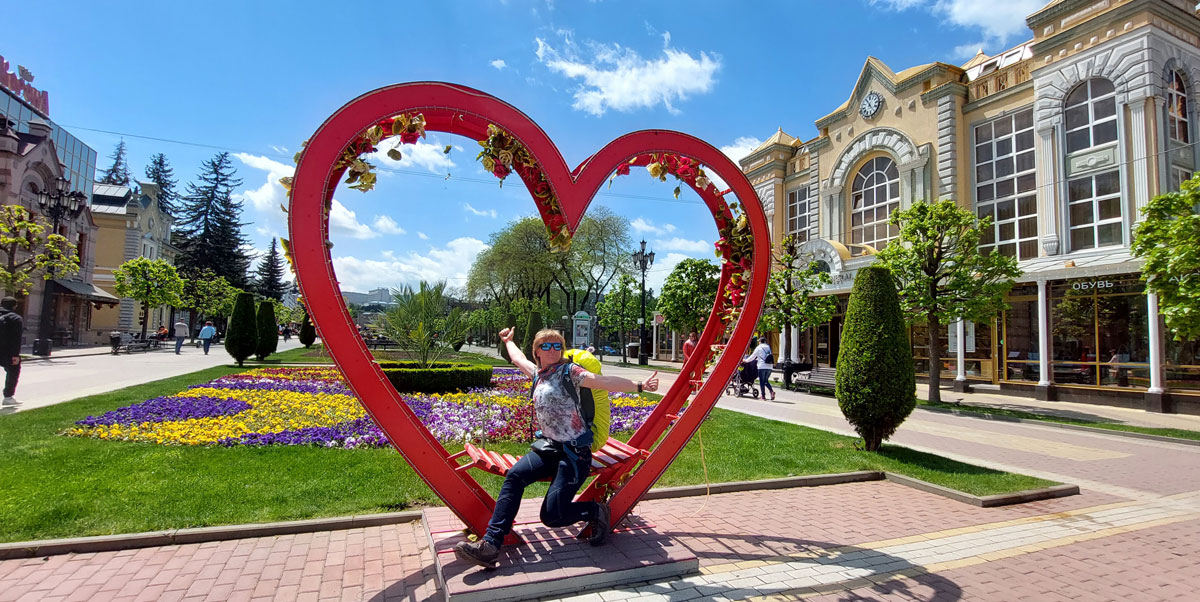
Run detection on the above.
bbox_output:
[289,82,770,542]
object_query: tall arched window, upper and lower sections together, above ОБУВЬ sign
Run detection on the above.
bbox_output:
[1063,79,1124,251]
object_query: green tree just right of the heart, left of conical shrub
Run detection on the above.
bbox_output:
[763,235,838,359]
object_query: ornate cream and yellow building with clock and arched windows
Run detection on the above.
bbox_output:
[742,0,1200,413]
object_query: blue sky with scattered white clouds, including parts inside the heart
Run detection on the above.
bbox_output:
[7,0,1044,291]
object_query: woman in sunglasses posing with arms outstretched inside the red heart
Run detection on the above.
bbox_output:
[454,327,659,568]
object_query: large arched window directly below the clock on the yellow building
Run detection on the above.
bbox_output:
[850,157,900,251]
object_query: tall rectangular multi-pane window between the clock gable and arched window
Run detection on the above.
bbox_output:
[974,108,1038,259]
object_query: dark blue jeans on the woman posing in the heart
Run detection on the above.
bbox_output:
[484,441,599,547]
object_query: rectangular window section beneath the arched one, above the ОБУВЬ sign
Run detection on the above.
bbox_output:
[1067,171,1124,251]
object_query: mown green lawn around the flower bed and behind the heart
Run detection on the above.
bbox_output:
[0,367,1050,542]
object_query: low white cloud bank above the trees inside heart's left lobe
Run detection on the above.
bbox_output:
[334,237,487,290]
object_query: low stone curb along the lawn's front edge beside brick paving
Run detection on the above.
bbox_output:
[0,470,1079,560]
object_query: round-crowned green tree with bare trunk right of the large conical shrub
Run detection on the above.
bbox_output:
[878,199,1021,402]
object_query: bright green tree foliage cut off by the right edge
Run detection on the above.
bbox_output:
[1130,177,1200,341]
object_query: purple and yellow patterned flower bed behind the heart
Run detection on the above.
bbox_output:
[65,367,658,447]
